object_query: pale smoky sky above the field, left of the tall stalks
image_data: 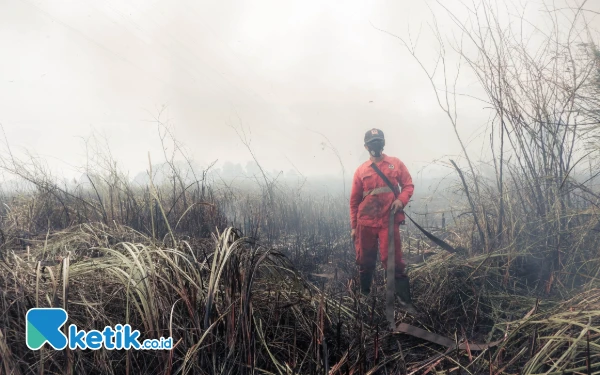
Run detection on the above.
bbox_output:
[0,0,600,182]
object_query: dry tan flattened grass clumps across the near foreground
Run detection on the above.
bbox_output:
[0,213,600,374]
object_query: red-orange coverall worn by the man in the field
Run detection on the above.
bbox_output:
[350,154,414,278]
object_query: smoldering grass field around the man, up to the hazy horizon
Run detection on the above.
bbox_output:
[0,128,600,374]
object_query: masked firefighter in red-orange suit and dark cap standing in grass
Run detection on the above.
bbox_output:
[350,129,414,310]
